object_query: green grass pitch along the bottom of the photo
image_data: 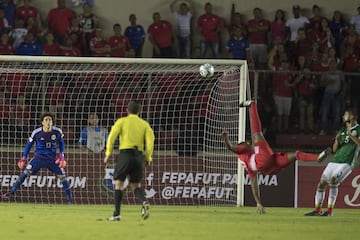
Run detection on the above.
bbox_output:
[0,203,360,240]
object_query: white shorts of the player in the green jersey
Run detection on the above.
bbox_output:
[321,162,352,185]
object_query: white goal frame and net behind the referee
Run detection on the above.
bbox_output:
[0,56,248,205]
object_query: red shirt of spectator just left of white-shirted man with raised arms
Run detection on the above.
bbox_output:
[148,20,173,48]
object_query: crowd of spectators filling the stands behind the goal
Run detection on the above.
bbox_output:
[0,0,360,148]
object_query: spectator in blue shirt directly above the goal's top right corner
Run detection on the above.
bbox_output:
[226,25,250,60]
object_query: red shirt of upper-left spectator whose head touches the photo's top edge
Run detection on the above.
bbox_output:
[46,8,74,37]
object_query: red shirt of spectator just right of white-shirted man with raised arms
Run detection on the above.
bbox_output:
[197,14,222,42]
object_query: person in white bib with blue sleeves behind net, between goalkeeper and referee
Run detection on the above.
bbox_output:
[78,113,108,153]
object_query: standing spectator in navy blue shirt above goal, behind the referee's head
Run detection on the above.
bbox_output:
[124,14,145,57]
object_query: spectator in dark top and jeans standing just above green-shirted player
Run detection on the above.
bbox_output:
[320,61,344,135]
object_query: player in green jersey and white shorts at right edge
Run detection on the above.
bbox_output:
[305,110,360,216]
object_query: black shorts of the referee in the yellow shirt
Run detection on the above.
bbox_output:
[114,148,144,183]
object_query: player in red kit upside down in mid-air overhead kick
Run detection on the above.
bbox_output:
[222,100,330,214]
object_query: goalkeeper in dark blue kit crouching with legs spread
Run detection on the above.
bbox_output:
[2,113,73,203]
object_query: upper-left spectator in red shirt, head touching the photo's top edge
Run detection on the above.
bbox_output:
[46,0,74,44]
